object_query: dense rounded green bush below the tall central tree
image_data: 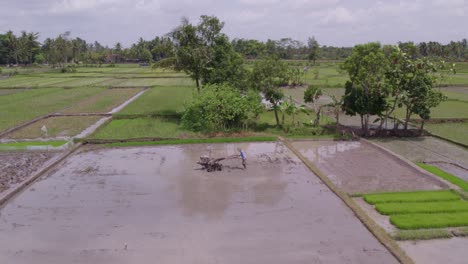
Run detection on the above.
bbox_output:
[182,85,261,132]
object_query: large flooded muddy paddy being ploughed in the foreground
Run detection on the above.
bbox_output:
[0,143,396,264]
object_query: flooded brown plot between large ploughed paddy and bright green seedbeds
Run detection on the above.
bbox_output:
[293,141,446,193]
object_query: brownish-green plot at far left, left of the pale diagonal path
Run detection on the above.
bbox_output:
[7,116,101,139]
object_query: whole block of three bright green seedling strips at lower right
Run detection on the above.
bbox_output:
[364,191,468,232]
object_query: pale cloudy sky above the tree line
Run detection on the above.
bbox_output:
[0,0,468,47]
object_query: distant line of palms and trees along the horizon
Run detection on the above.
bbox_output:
[0,27,468,66]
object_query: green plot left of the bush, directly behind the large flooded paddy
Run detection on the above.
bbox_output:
[92,118,193,139]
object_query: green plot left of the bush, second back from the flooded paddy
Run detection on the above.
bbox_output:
[119,86,195,115]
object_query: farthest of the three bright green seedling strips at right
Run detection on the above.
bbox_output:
[364,190,460,204]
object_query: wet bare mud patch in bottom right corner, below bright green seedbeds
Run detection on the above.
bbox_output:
[398,237,468,264]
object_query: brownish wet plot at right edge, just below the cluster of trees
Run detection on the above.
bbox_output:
[374,137,468,181]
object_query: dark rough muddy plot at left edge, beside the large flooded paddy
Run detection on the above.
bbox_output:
[0,152,58,193]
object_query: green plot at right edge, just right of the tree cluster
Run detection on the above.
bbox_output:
[425,122,468,145]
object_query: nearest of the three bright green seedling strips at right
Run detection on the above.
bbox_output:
[390,212,468,229]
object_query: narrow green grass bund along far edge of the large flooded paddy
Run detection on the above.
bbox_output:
[105,136,277,147]
